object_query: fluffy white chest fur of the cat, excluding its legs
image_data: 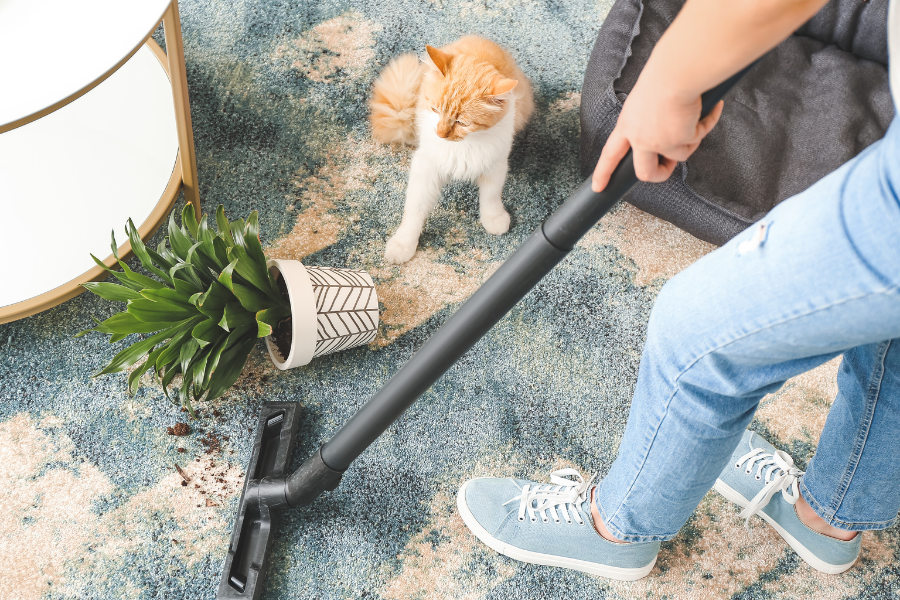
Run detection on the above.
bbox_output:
[416,98,516,180]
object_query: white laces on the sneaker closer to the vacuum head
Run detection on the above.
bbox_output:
[503,468,594,525]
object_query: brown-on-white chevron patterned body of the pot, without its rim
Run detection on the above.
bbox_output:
[306,267,378,357]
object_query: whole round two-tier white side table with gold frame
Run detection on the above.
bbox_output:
[0,0,200,323]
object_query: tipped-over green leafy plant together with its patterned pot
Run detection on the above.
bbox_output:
[78,205,378,414]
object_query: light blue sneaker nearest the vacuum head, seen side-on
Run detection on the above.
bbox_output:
[456,469,659,581]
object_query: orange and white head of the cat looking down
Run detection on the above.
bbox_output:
[422,46,517,142]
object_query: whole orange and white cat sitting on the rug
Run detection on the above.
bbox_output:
[369,36,534,264]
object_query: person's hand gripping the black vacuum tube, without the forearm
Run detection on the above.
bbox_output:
[591,69,724,192]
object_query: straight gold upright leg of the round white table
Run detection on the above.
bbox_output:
[163,0,200,219]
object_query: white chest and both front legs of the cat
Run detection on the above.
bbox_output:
[384,98,516,264]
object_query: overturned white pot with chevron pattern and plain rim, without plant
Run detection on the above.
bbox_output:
[266,259,378,370]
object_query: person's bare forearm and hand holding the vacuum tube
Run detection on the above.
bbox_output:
[591,0,827,192]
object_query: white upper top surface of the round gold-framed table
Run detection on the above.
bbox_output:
[0,0,171,127]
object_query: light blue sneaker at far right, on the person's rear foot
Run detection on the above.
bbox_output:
[714,431,862,575]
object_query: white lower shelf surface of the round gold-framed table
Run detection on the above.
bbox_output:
[0,46,178,307]
